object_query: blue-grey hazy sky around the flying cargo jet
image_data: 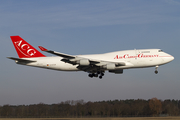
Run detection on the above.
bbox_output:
[0,0,180,105]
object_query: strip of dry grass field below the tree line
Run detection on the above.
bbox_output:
[0,117,180,120]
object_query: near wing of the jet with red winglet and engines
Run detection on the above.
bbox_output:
[38,46,126,71]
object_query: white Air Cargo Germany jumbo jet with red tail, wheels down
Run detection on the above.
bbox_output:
[8,36,174,79]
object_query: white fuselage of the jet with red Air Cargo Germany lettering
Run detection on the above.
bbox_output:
[17,49,174,71]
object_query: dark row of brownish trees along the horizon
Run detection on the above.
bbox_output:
[0,98,180,118]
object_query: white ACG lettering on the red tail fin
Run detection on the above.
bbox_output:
[14,40,36,56]
